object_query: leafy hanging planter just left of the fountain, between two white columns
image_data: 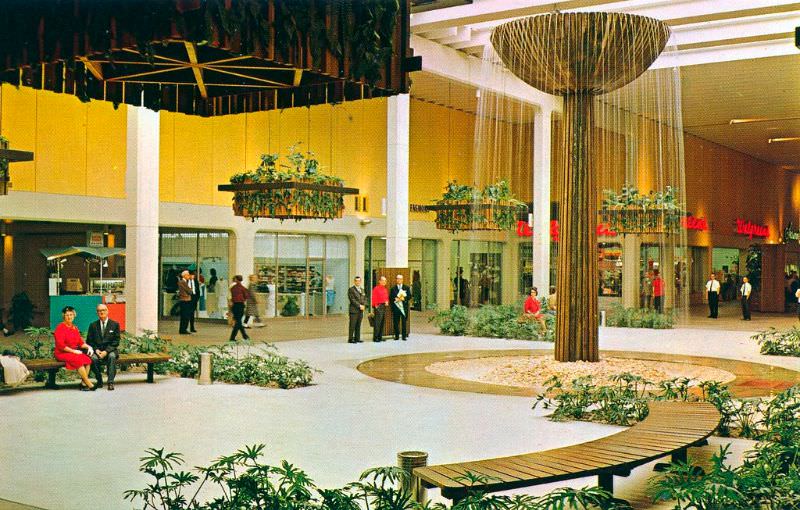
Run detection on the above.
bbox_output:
[417,181,528,233]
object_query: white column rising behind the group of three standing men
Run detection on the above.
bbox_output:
[386,94,411,267]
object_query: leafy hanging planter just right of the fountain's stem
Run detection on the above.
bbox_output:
[600,186,686,235]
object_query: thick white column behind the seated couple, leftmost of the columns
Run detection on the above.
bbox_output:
[125,106,160,334]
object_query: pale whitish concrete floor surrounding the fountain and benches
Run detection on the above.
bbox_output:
[0,300,800,510]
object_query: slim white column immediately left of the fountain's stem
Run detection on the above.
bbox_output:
[532,108,555,296]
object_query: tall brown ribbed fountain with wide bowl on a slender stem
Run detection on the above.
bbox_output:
[491,12,670,361]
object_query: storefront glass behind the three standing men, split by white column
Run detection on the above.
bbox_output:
[364,237,438,310]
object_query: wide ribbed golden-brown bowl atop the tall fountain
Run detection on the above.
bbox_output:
[491,12,670,95]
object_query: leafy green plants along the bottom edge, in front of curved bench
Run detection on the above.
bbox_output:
[124,444,627,510]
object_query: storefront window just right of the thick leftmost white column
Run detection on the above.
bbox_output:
[159,232,230,319]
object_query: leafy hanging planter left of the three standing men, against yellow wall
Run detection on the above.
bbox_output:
[217,145,358,221]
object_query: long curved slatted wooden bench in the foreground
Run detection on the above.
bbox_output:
[413,402,721,501]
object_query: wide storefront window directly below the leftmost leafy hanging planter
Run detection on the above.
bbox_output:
[254,233,350,317]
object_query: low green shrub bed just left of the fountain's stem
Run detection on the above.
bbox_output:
[429,298,556,342]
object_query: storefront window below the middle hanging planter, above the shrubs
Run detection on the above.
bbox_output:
[450,241,504,307]
